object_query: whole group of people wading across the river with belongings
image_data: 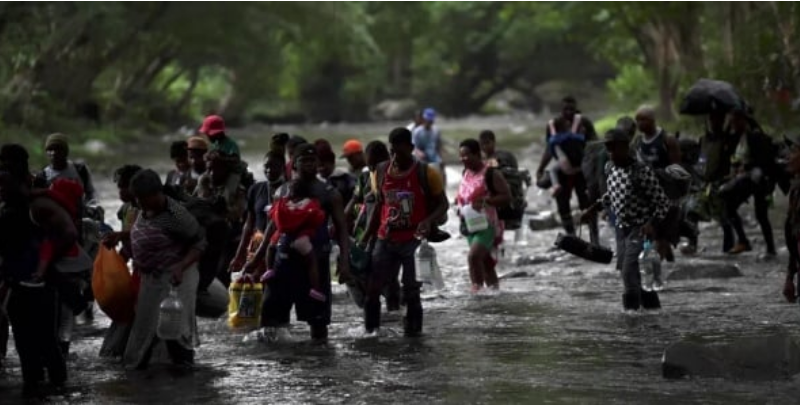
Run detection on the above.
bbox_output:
[0,97,800,393]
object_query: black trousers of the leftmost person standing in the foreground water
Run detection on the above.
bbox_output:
[8,285,67,385]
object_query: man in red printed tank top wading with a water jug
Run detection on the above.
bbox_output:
[362,127,448,337]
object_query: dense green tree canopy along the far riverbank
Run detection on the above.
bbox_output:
[0,2,800,134]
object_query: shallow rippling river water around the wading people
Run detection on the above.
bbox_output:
[0,119,800,404]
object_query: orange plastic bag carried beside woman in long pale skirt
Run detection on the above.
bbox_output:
[92,245,136,323]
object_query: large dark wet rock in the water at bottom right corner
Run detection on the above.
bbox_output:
[662,331,800,380]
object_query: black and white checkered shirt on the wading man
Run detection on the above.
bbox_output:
[602,162,670,228]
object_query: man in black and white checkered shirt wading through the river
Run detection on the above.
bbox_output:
[581,129,670,310]
